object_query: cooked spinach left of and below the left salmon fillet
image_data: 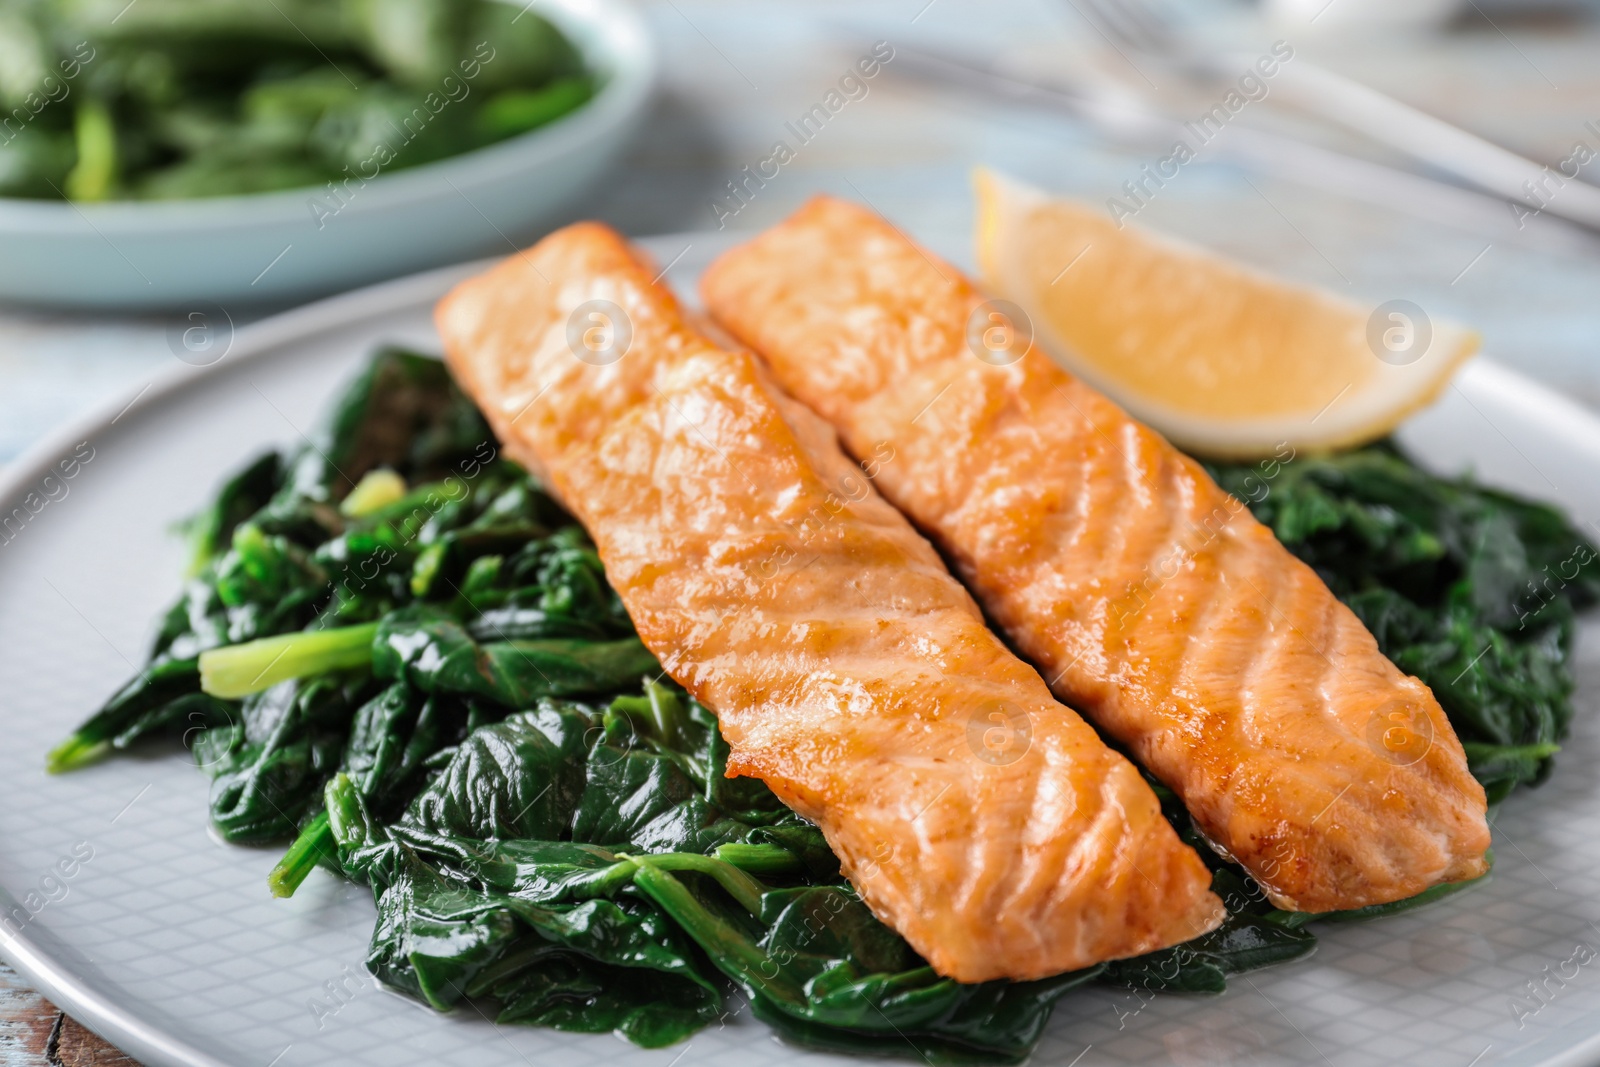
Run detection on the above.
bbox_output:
[50,350,1101,1064]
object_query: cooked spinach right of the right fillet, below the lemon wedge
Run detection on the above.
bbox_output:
[1211,443,1600,803]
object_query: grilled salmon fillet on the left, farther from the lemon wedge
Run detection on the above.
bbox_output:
[437,224,1222,982]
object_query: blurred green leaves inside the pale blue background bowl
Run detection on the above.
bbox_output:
[0,0,595,202]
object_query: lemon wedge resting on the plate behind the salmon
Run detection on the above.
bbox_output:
[974,170,1478,459]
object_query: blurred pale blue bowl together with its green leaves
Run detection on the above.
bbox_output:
[0,0,656,308]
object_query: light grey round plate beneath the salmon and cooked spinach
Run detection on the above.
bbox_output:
[0,235,1600,1067]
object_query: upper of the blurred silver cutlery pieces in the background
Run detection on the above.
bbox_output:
[1067,0,1600,229]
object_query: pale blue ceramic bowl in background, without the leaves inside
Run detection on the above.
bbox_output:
[0,0,656,310]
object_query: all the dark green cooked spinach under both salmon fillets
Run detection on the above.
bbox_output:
[50,349,1600,1064]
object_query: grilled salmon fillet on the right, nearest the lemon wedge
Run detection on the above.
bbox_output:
[701,197,1490,912]
